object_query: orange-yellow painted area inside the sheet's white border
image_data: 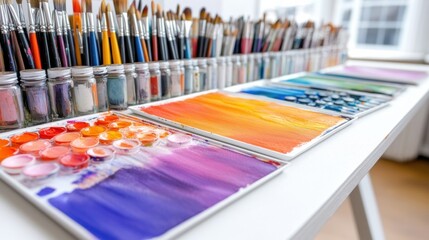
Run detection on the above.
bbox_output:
[141,92,347,154]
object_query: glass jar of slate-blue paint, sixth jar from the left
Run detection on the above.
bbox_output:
[107,64,128,110]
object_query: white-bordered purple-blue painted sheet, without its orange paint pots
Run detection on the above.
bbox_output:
[0,115,286,239]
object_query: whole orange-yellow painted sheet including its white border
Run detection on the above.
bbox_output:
[130,90,353,160]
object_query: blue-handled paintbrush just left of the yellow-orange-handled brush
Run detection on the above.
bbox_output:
[82,0,100,66]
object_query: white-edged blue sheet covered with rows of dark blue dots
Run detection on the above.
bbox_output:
[225,80,392,117]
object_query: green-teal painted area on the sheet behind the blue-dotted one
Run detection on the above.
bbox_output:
[280,75,402,96]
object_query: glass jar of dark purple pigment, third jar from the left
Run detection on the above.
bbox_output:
[48,68,74,120]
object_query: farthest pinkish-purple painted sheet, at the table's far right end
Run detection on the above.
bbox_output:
[320,65,428,85]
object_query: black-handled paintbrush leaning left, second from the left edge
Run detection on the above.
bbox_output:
[7,0,34,69]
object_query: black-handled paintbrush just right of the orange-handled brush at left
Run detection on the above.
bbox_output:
[40,0,61,67]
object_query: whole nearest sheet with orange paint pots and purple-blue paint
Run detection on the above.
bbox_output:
[0,113,287,239]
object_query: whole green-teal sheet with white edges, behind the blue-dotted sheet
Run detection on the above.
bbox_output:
[271,73,405,97]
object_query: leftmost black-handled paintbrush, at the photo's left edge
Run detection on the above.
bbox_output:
[0,0,17,72]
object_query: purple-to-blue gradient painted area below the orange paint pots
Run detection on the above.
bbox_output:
[48,143,278,239]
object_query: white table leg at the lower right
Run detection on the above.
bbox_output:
[349,174,384,240]
